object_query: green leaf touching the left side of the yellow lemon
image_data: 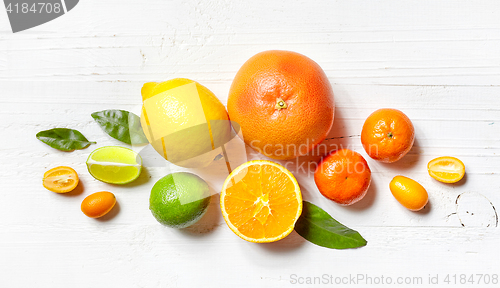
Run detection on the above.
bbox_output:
[92,110,148,144]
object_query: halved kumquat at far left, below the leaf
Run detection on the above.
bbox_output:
[43,166,79,193]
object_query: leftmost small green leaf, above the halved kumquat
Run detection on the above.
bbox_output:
[36,128,96,151]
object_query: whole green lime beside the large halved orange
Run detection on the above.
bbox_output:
[149,172,211,228]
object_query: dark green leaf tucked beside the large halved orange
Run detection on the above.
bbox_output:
[295,201,366,249]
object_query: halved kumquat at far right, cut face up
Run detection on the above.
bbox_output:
[427,156,465,183]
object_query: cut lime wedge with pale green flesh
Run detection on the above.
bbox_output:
[87,146,142,184]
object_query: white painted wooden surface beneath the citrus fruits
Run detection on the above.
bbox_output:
[0,0,500,287]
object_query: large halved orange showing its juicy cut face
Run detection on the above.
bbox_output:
[220,160,302,243]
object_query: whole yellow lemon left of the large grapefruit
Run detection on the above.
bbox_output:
[141,78,231,168]
